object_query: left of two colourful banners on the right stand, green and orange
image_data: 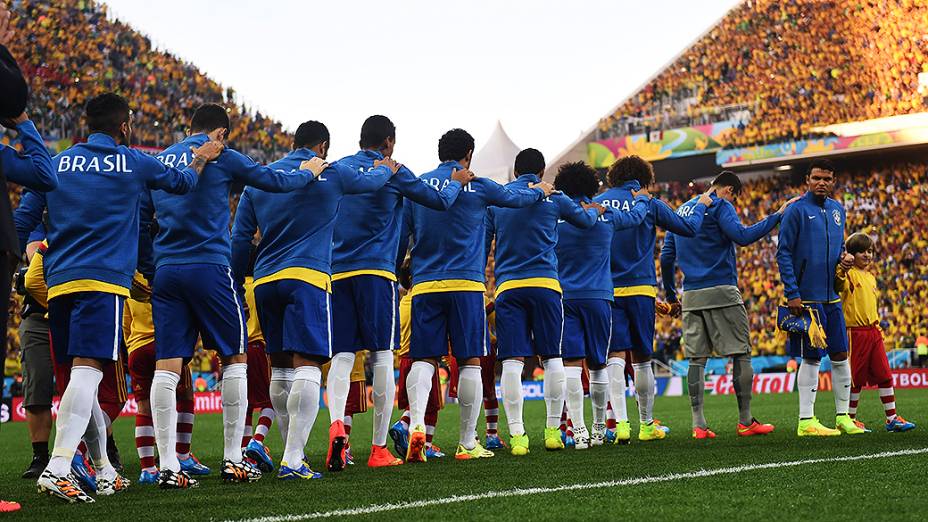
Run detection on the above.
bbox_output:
[587,120,738,168]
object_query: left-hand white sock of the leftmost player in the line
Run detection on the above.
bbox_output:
[47,366,103,476]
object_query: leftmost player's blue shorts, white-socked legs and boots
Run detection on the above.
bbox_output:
[38,292,128,502]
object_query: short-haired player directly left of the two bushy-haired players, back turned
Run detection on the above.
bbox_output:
[484,149,605,455]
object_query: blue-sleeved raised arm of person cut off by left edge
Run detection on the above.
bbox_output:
[0,113,58,192]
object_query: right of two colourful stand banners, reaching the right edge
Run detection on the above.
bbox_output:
[715,128,928,167]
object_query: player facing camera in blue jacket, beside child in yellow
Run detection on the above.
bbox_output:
[777,160,864,437]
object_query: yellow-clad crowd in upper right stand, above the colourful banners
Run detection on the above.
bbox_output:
[599,0,928,146]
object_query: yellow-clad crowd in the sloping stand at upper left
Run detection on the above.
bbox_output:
[0,0,291,161]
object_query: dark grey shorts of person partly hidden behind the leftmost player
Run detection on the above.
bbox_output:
[19,314,55,408]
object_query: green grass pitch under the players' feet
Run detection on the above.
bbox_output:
[0,390,928,522]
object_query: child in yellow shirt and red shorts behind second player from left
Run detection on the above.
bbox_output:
[122,272,210,484]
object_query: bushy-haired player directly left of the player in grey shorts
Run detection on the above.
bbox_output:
[593,156,712,443]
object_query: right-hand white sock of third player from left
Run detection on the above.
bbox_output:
[281,366,322,469]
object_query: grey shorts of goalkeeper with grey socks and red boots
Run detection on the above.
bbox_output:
[683,304,751,359]
